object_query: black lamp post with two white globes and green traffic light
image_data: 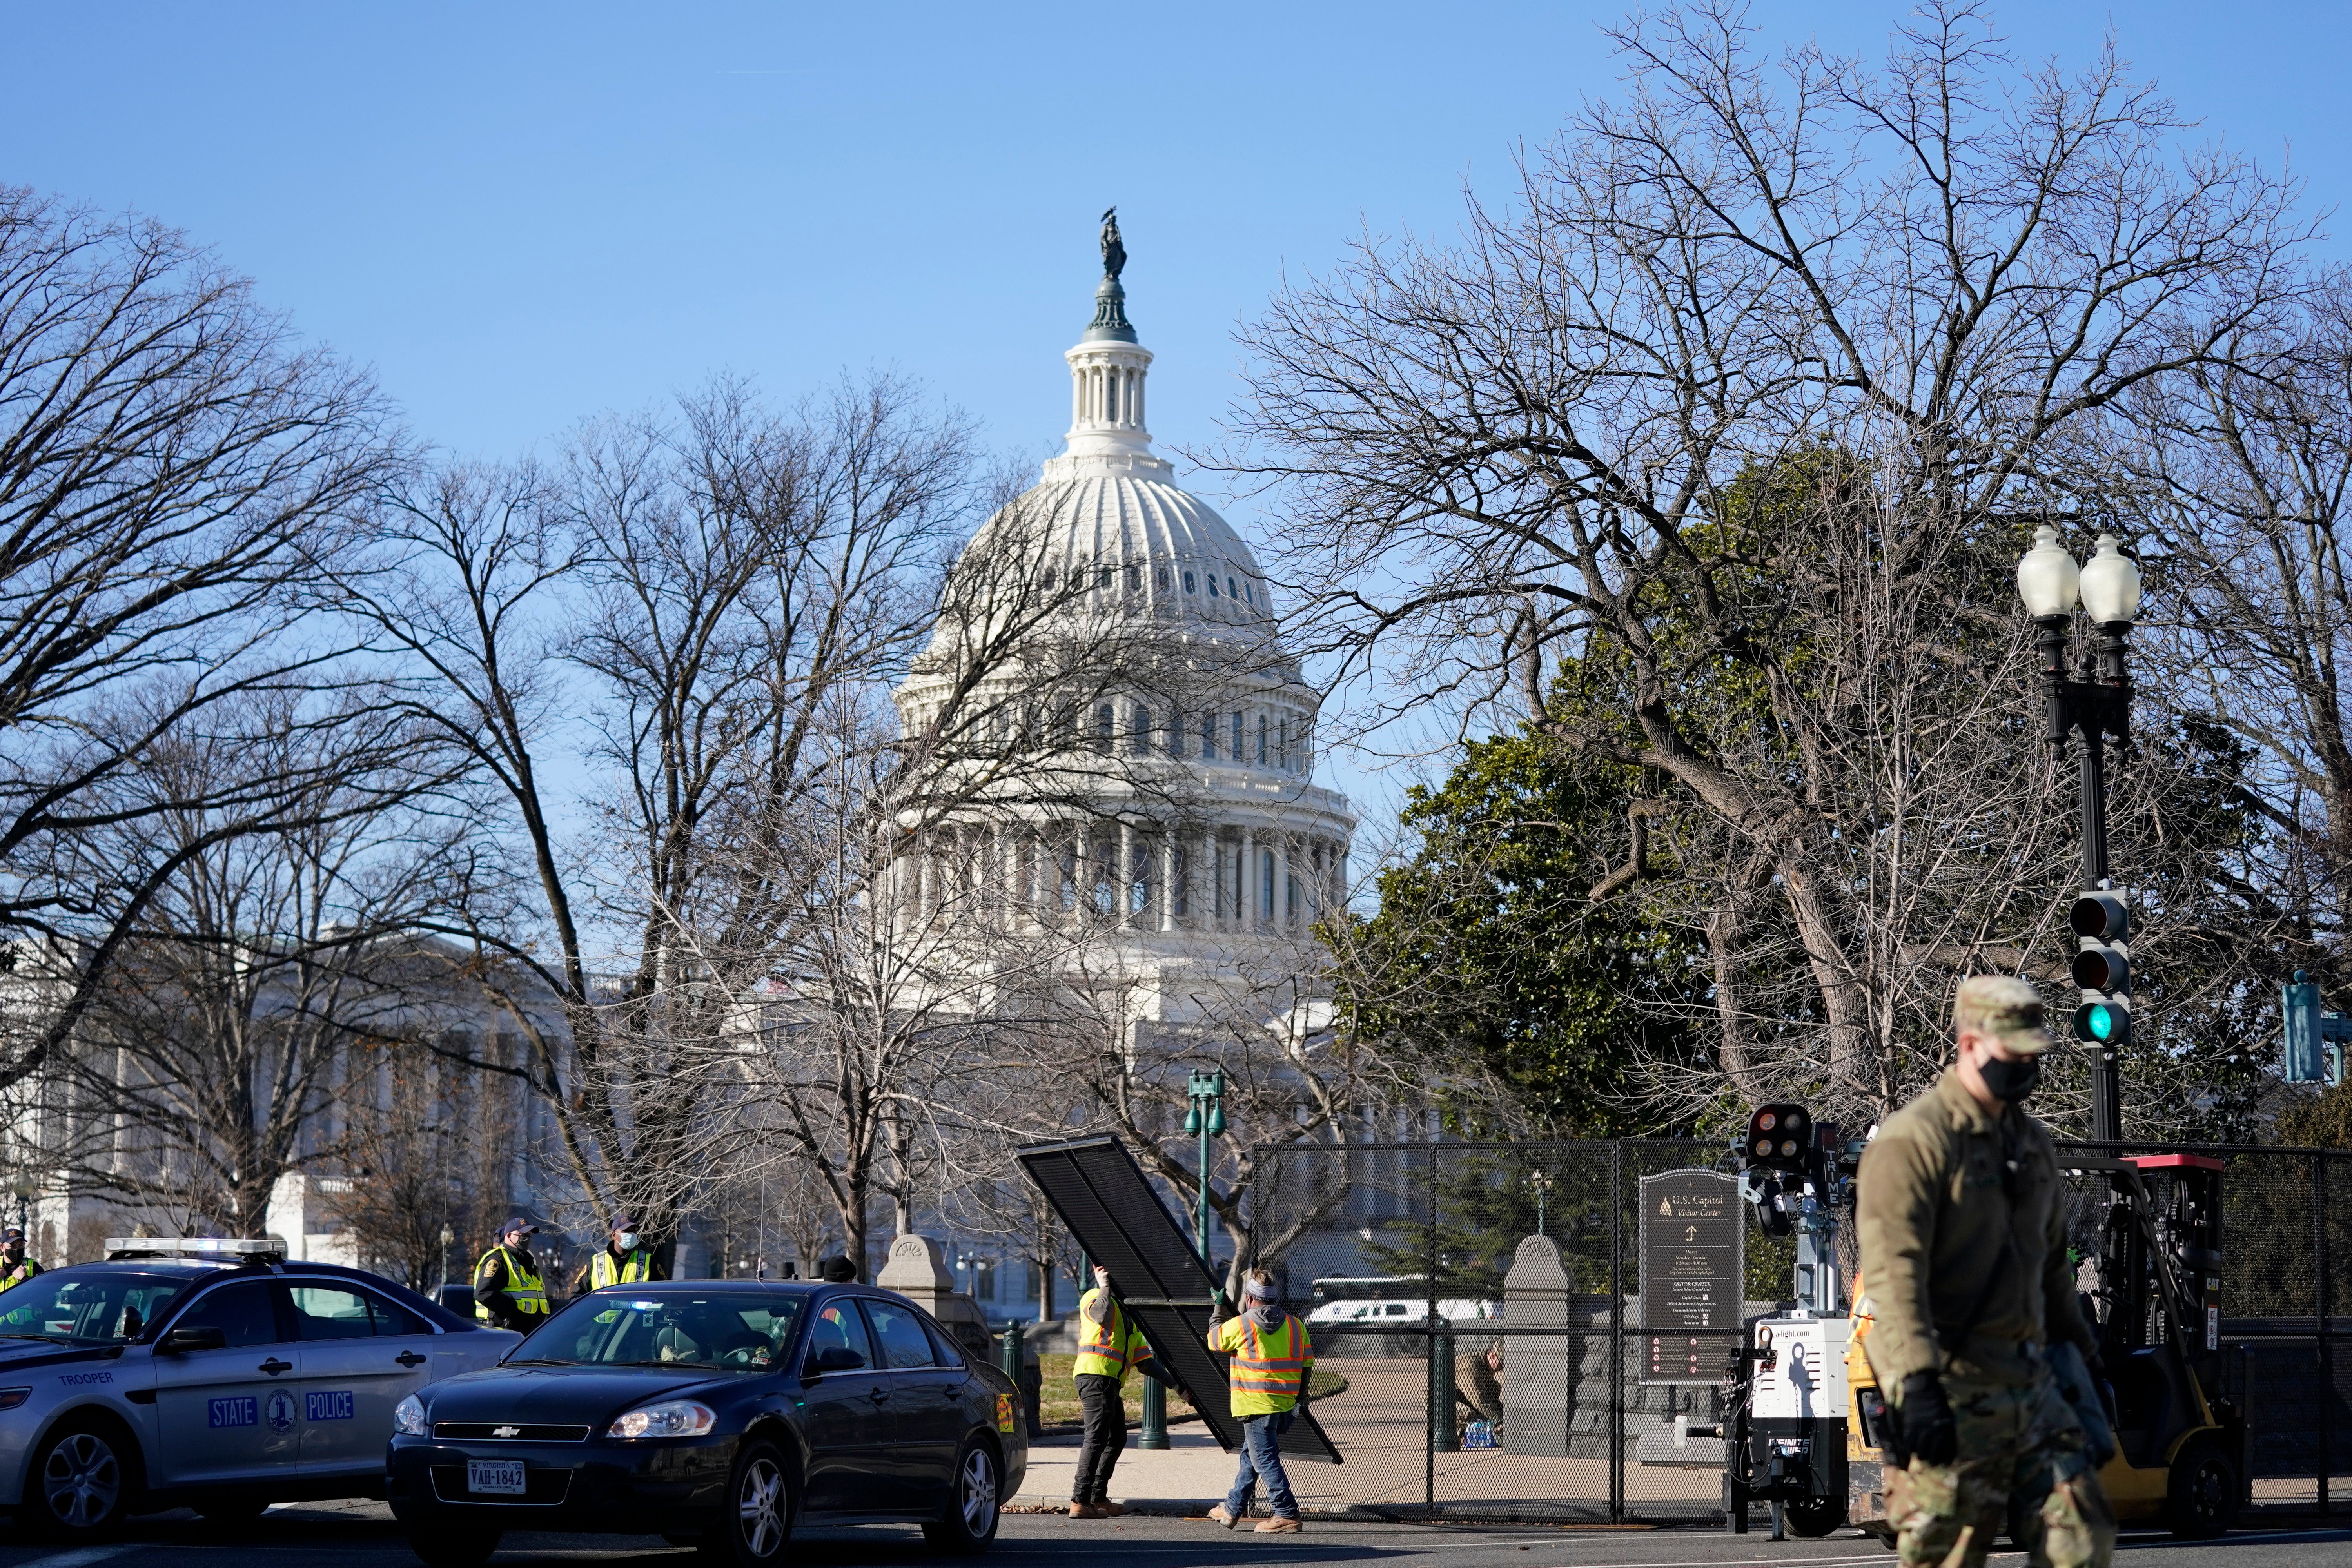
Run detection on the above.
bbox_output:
[2018,522,2140,1143]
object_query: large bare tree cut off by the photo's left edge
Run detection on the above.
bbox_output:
[0,186,402,1084]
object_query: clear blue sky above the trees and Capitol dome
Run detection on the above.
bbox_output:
[0,0,2352,832]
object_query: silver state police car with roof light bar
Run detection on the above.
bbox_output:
[0,1236,520,1540]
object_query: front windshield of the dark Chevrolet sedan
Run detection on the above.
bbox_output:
[506,1286,800,1373]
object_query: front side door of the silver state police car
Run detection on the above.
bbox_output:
[155,1279,301,1486]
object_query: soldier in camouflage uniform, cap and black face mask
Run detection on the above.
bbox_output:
[1856,976,2114,1568]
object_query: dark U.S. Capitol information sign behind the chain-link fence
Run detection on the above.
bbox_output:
[1639,1171,1748,1385]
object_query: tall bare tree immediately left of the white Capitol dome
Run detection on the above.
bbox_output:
[341,381,969,1232]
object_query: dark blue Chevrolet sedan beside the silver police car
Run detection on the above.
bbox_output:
[386,1279,1028,1566]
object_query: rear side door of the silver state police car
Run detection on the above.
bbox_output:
[287,1279,433,1476]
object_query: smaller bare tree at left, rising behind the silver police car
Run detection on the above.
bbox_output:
[36,703,463,1236]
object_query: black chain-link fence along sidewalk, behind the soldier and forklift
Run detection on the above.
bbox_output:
[1251,1140,2352,1523]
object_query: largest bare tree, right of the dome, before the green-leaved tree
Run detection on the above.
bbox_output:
[1235,5,2300,1117]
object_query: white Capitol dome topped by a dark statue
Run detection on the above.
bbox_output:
[891,214,1355,1025]
